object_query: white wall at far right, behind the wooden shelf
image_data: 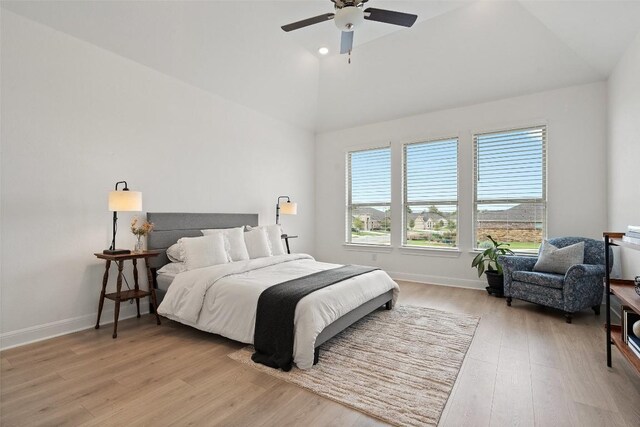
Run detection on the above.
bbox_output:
[608,34,640,278]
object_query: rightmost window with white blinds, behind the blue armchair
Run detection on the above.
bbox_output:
[474,126,547,251]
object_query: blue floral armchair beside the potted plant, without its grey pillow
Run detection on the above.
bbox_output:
[498,237,613,323]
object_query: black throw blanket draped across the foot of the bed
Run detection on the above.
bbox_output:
[251,265,377,371]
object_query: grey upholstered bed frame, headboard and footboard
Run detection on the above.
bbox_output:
[147,212,393,363]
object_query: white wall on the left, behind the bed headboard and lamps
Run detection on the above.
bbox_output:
[0,11,314,347]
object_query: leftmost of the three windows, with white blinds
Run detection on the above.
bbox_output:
[346,147,391,245]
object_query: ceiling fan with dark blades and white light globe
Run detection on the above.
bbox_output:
[282,0,418,53]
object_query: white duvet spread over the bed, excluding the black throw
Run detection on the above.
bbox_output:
[158,254,399,369]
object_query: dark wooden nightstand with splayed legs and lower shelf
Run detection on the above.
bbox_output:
[94,251,160,338]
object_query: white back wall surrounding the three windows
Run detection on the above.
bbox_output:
[316,83,607,287]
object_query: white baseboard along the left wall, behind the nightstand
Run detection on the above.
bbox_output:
[0,304,149,350]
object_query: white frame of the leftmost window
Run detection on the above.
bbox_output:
[344,144,393,248]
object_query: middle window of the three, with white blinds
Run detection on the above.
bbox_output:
[404,139,458,247]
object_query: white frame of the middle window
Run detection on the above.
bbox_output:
[401,135,460,251]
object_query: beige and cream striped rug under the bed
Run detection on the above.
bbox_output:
[229,305,479,426]
